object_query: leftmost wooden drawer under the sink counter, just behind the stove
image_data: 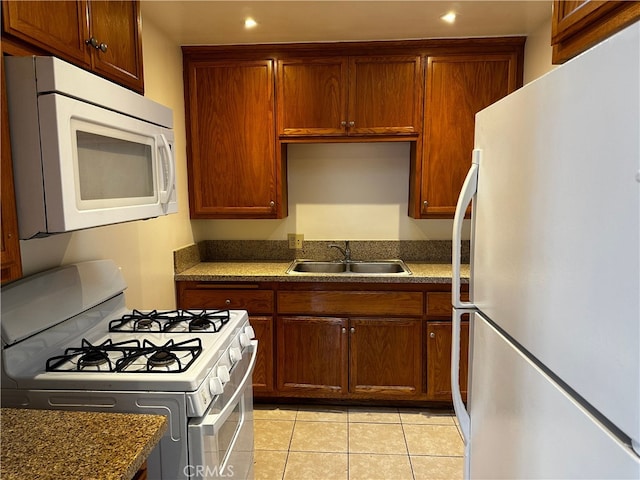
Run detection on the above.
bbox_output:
[180,289,273,314]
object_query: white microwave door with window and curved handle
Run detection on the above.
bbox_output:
[16,94,177,238]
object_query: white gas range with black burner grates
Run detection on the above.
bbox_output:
[1,260,257,480]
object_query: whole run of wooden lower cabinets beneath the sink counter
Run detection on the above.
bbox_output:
[176,282,469,403]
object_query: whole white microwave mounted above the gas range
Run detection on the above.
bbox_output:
[5,57,178,239]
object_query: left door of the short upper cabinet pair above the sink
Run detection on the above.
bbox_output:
[277,57,348,136]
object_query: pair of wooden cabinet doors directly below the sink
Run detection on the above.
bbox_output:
[276,316,422,399]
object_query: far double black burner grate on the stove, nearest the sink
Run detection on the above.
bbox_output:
[109,310,229,333]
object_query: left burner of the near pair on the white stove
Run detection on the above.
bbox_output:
[46,338,141,372]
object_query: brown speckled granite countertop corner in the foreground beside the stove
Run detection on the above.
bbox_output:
[0,408,168,480]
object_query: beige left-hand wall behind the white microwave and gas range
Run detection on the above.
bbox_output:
[20,20,193,309]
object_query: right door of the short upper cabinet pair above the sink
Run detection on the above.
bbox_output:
[346,56,422,136]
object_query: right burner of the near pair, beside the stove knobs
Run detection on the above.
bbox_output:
[115,338,202,373]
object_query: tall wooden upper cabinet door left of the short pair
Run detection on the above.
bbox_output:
[185,60,280,218]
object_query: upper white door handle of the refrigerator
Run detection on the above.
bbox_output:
[451,149,482,308]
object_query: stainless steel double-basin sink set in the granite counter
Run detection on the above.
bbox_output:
[287,260,411,275]
